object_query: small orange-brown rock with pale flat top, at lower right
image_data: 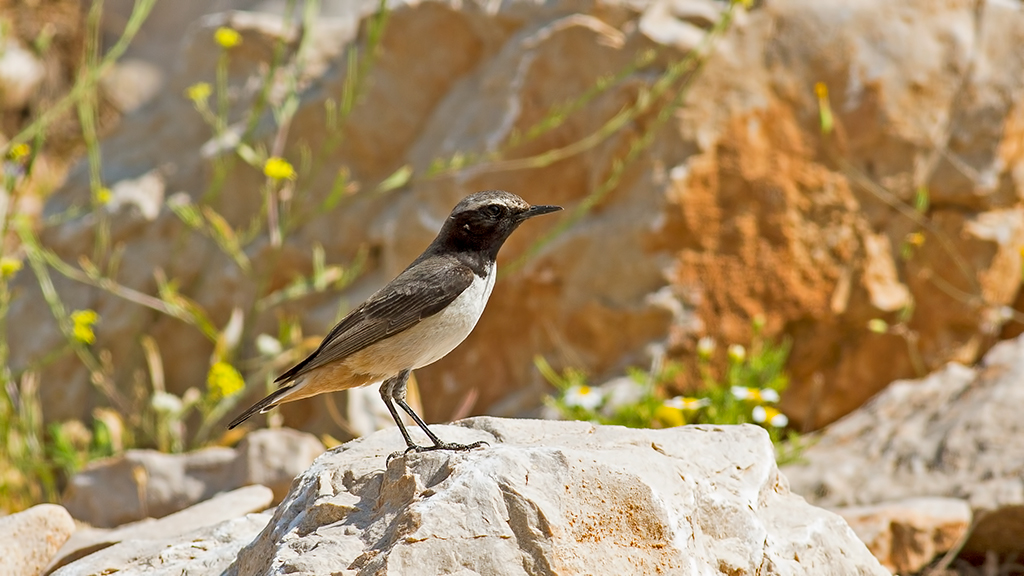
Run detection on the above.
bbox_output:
[834,497,971,574]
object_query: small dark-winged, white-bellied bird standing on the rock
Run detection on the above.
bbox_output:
[227,190,562,460]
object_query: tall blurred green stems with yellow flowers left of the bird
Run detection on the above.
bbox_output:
[0,0,387,511]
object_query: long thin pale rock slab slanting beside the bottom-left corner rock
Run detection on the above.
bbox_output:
[48,485,273,571]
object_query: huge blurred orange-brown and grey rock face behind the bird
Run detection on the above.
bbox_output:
[8,0,1024,429]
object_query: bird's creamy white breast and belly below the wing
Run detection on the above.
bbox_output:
[342,268,497,378]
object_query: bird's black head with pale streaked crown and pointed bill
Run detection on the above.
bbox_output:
[435,190,562,258]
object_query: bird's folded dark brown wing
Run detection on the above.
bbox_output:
[274,262,474,383]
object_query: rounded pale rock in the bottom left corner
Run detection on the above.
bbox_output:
[0,504,75,576]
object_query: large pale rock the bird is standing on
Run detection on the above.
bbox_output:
[227,417,886,576]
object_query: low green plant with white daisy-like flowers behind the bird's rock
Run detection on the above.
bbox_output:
[535,321,800,461]
